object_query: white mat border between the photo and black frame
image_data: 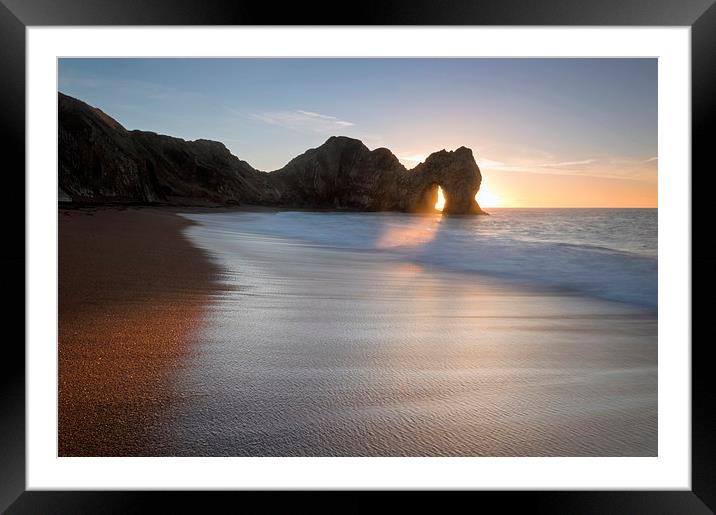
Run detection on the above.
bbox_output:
[26,27,691,490]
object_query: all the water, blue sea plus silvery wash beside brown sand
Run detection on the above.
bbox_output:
[164,210,658,456]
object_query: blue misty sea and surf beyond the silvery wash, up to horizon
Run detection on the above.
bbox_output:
[183,208,658,310]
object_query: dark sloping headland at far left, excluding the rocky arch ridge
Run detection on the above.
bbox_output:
[58,93,279,204]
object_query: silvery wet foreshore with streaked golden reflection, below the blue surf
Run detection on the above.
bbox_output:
[161,216,657,456]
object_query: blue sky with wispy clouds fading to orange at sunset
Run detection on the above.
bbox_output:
[58,58,658,207]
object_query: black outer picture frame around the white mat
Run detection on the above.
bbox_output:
[0,0,716,514]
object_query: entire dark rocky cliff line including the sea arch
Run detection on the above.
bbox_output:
[58,93,482,214]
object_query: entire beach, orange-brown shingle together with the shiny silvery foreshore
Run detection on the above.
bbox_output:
[60,210,657,456]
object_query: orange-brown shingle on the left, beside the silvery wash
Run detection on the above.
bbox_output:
[58,208,216,456]
